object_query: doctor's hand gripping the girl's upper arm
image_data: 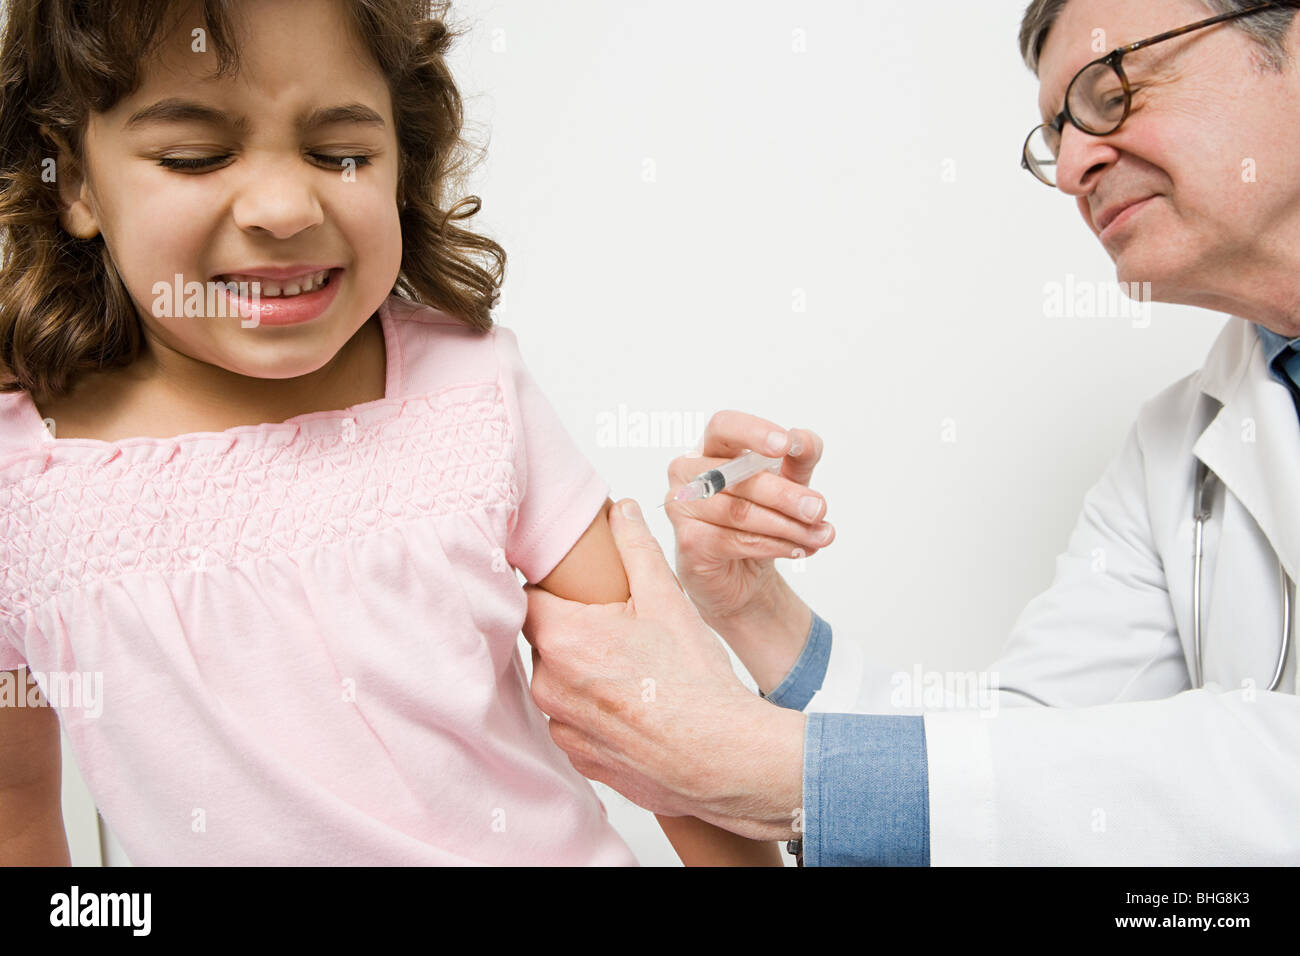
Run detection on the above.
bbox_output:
[523,499,805,840]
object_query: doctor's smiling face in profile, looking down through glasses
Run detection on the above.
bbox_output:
[1039,0,1300,325]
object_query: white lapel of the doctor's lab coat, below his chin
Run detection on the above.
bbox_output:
[1192,317,1300,580]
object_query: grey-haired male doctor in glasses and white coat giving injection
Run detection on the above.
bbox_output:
[524,0,1300,865]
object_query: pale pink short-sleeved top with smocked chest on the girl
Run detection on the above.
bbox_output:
[0,297,637,865]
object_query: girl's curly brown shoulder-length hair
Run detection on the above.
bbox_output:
[0,0,506,401]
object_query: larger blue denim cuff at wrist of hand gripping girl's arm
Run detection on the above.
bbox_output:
[803,713,930,866]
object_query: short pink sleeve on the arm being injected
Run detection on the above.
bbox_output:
[493,325,610,584]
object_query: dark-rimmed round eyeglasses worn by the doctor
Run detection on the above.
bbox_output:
[1021,0,1300,186]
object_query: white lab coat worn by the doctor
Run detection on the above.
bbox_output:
[807,317,1300,865]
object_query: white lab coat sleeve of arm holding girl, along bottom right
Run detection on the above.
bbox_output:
[924,689,1300,866]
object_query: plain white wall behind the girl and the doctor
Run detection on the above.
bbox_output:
[66,0,1225,864]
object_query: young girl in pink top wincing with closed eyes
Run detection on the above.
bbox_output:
[0,0,779,865]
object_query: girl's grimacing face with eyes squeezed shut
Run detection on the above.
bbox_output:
[59,0,402,390]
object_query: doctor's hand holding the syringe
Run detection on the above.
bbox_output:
[666,411,835,692]
